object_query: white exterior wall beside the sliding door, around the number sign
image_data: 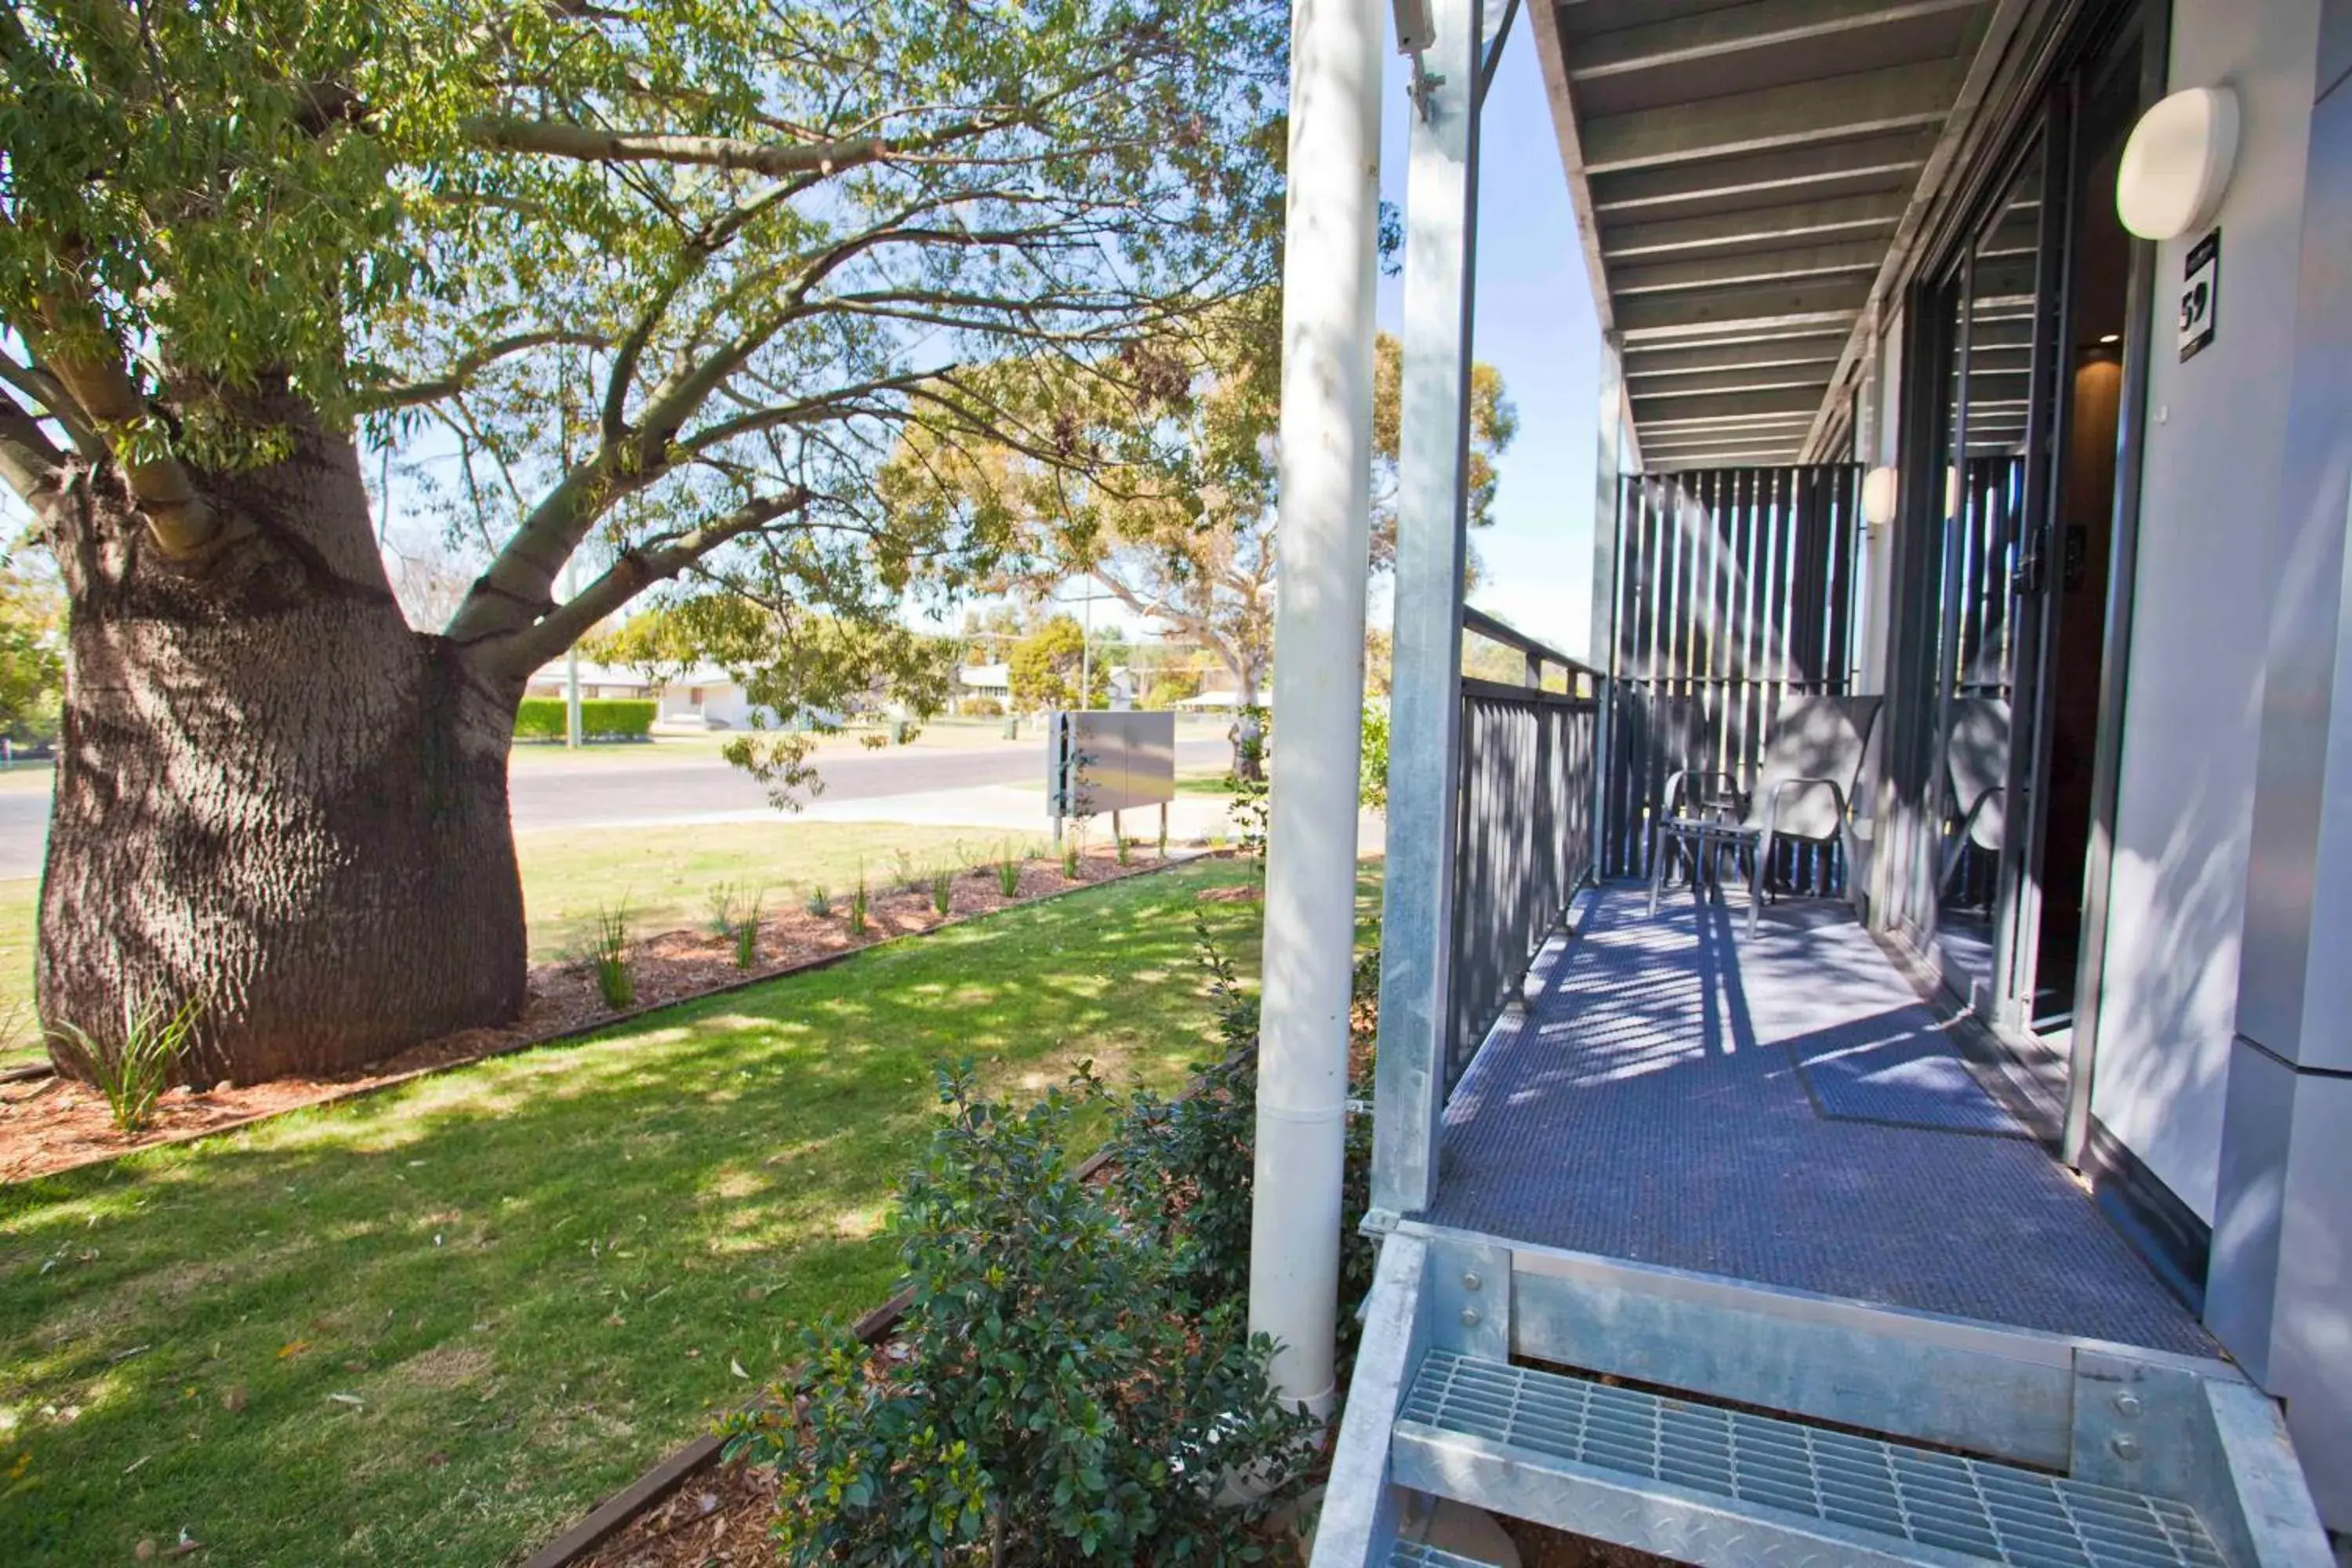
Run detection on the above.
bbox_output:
[2091,0,2319,1220]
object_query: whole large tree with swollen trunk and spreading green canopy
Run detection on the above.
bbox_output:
[0,0,1284,1079]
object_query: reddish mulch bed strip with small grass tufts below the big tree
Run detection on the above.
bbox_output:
[0,846,1195,1182]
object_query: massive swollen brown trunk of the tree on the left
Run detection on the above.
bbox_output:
[38,421,524,1083]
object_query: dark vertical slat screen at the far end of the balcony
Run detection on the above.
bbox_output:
[1599,463,1863,891]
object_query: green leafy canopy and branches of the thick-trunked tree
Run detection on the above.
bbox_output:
[0,0,1284,675]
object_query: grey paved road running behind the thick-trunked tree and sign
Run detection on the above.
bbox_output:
[0,739,1230,877]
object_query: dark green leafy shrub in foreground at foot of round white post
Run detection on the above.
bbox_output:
[724,1062,1312,1568]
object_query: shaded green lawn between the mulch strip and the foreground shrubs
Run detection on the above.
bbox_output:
[0,862,1327,1563]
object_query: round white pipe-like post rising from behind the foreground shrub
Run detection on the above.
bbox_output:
[1244,0,1388,1415]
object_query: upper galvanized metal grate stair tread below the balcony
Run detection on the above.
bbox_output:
[1397,1349,2225,1568]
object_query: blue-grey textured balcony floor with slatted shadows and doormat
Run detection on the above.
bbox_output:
[1428,886,2216,1354]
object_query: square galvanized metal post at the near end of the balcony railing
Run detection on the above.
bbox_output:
[1371,0,1477,1213]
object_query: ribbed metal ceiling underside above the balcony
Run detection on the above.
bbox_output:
[1548,0,1994,470]
